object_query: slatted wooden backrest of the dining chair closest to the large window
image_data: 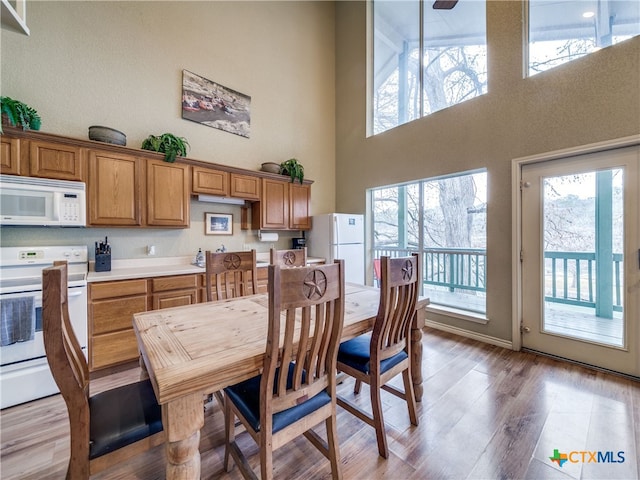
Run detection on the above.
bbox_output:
[371,254,421,361]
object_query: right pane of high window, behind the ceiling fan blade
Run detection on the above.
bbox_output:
[423,1,487,115]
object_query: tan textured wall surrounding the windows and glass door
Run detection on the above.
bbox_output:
[336,1,640,340]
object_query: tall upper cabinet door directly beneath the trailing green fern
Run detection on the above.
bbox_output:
[147,160,191,228]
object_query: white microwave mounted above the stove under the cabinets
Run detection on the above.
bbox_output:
[0,175,87,227]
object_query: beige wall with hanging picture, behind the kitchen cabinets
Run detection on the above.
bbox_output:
[0,1,335,258]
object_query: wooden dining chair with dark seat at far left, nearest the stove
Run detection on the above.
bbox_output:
[42,262,165,480]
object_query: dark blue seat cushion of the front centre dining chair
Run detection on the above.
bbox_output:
[224,363,331,433]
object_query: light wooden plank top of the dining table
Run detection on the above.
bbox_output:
[133,284,428,404]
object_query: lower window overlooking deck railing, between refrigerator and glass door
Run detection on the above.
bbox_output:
[370,170,487,314]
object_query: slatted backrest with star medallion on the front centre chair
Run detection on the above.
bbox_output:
[261,260,344,414]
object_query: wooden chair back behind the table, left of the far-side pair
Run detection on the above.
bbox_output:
[205,250,258,302]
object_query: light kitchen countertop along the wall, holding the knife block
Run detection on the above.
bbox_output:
[87,253,325,283]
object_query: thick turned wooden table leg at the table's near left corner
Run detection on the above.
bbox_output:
[162,393,204,480]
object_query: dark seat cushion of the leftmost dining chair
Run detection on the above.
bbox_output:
[89,380,162,459]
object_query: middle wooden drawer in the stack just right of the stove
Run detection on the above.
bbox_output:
[90,296,147,335]
